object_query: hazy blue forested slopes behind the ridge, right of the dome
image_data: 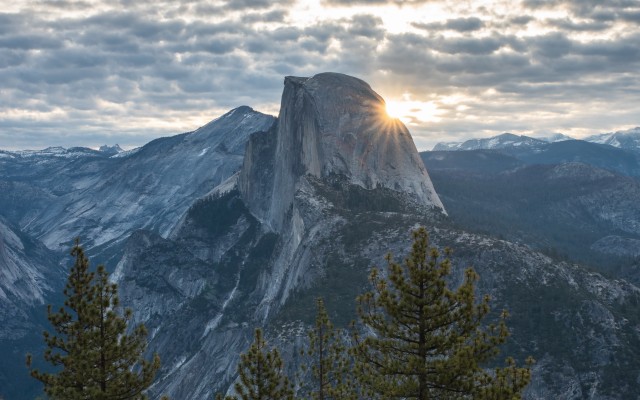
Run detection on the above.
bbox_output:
[421,150,640,284]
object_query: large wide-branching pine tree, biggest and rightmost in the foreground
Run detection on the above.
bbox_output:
[353,228,532,400]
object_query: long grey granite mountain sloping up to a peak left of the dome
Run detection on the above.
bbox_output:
[0,107,274,266]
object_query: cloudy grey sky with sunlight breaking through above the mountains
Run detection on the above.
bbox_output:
[0,0,640,149]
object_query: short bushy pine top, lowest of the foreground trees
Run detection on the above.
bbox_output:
[216,329,293,400]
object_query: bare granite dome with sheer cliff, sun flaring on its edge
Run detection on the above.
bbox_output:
[239,73,444,231]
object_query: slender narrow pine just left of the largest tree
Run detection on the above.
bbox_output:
[302,298,358,400]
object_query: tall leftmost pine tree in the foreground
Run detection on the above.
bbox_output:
[27,239,160,400]
